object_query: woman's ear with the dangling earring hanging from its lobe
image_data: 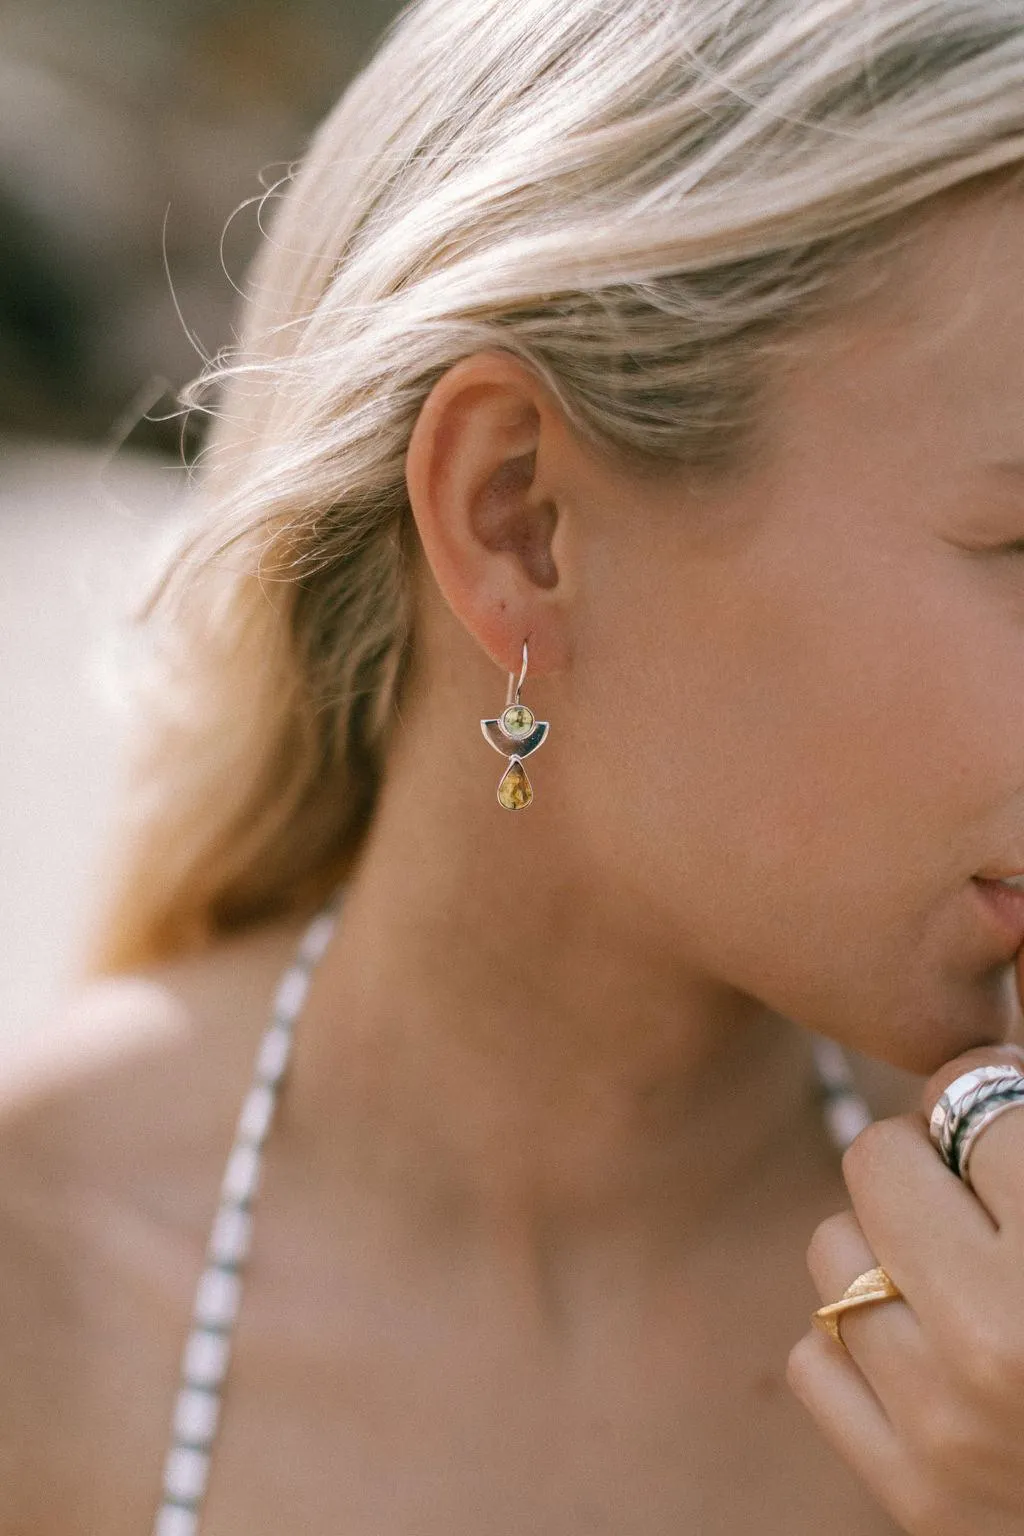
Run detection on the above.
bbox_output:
[405,352,579,676]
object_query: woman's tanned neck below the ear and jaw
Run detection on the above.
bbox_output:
[289,724,817,1241]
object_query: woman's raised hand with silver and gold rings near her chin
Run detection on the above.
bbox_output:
[788,1046,1024,1536]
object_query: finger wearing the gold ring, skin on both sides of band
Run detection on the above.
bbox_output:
[808,1210,935,1424]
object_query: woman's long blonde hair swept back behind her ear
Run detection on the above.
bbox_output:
[82,0,1024,971]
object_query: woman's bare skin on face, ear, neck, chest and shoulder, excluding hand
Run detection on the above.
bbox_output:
[0,176,1024,1536]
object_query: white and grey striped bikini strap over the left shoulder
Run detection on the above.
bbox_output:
[154,888,342,1536]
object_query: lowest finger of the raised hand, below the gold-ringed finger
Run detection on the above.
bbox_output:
[786,1333,913,1522]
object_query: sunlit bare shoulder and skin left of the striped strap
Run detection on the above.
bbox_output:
[0,922,308,1536]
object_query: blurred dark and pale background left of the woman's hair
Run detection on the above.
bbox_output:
[0,0,401,1037]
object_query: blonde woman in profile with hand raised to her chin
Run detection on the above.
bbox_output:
[0,0,1024,1536]
